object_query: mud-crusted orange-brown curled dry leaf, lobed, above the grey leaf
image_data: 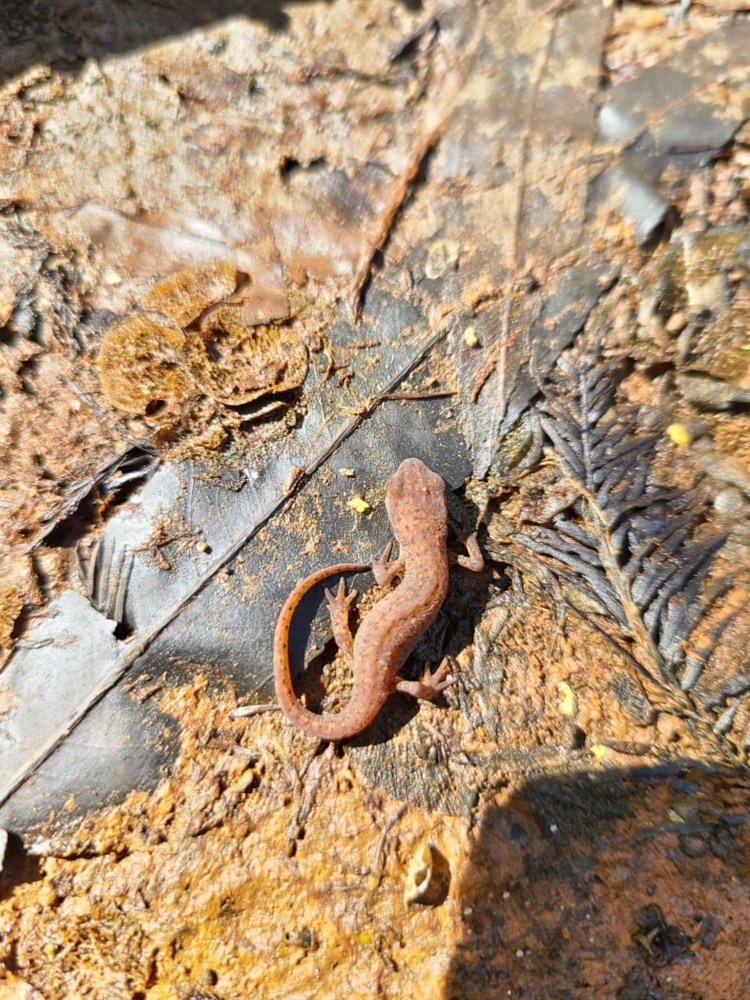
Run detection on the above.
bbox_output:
[97,260,307,440]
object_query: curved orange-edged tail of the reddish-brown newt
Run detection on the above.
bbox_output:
[273,563,370,740]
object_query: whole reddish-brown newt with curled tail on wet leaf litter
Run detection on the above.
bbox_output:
[273,458,484,740]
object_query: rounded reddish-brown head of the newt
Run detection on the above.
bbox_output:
[385,458,448,544]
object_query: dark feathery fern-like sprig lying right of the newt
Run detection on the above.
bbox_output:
[517,359,732,744]
